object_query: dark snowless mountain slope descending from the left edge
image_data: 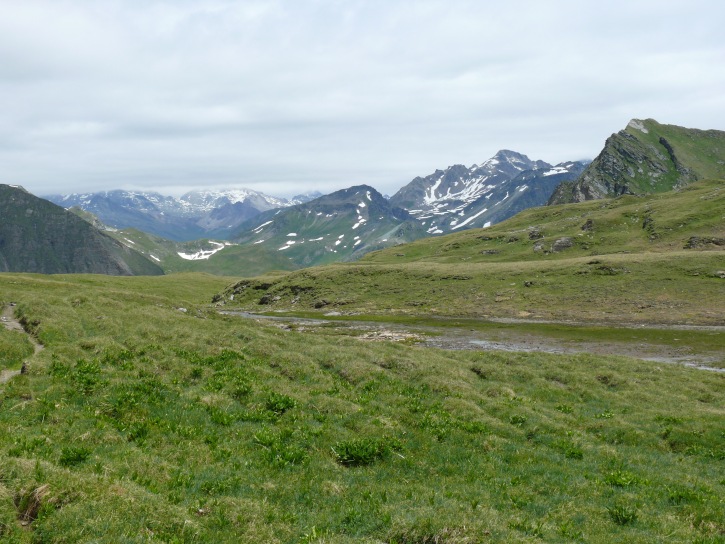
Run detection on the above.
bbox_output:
[0,185,163,276]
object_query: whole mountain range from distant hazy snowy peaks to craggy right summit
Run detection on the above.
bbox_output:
[5,119,725,276]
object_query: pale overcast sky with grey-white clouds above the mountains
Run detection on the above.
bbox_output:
[0,0,725,197]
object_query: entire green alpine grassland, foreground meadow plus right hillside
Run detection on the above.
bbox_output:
[0,172,725,544]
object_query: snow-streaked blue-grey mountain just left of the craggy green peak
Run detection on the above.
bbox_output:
[390,150,586,235]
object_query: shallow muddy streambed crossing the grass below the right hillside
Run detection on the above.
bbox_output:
[221,311,725,373]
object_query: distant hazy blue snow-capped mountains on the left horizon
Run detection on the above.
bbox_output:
[45,189,296,241]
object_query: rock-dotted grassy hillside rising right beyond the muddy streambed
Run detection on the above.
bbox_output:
[217,181,725,325]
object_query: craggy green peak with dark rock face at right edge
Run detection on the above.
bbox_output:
[549,119,725,204]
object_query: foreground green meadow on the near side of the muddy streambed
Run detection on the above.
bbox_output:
[0,275,725,543]
